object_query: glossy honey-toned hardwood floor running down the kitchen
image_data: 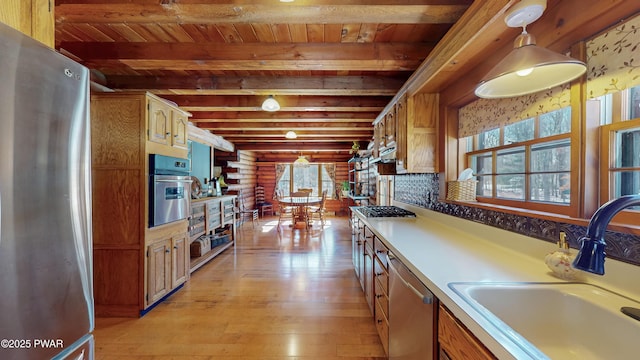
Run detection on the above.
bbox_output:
[94,217,386,360]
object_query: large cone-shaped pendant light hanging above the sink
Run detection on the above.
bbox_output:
[475,0,587,99]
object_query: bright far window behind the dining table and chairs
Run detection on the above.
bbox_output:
[276,164,335,198]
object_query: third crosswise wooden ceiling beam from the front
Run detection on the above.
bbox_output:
[106,75,404,96]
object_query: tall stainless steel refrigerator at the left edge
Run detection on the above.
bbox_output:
[0,23,94,360]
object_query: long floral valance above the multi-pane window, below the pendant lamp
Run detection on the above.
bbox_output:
[458,84,570,138]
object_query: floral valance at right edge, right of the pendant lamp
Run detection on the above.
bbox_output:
[586,12,640,98]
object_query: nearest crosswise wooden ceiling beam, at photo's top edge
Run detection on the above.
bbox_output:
[55,0,468,24]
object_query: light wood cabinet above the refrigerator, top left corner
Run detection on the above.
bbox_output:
[0,0,55,48]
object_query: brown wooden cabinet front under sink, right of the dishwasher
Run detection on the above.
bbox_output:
[438,304,497,360]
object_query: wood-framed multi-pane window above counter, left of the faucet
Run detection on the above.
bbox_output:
[466,107,571,214]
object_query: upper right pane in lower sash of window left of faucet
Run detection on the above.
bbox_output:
[531,139,571,172]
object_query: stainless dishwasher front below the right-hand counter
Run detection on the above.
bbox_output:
[387,252,437,360]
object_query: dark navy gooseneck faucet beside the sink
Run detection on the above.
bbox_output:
[572,195,640,275]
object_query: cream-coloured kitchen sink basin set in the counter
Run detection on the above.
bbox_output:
[449,282,640,360]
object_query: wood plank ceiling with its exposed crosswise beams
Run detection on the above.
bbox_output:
[55,0,472,160]
